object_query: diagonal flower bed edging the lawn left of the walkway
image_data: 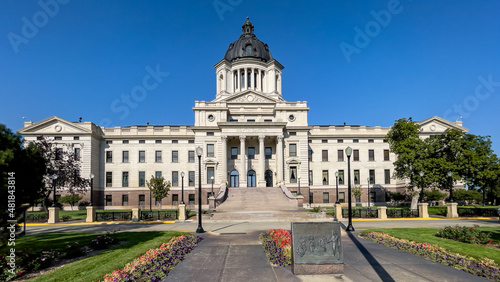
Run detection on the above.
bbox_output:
[104,235,203,281]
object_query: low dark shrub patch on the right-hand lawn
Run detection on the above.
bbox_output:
[436,225,493,244]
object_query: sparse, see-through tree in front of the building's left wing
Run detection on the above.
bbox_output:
[33,137,90,212]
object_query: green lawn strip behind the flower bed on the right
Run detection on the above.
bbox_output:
[362,227,500,263]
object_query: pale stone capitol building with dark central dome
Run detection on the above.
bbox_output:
[19,18,467,209]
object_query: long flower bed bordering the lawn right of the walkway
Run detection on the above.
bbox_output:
[360,232,500,281]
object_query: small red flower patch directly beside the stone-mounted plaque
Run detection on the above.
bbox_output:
[259,229,292,266]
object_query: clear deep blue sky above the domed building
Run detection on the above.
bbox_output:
[0,0,500,153]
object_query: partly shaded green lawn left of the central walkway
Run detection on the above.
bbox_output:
[16,231,185,281]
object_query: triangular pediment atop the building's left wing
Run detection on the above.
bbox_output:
[19,116,91,135]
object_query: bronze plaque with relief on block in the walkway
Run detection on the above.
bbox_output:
[292,222,344,264]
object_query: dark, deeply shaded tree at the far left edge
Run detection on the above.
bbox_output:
[0,124,45,247]
